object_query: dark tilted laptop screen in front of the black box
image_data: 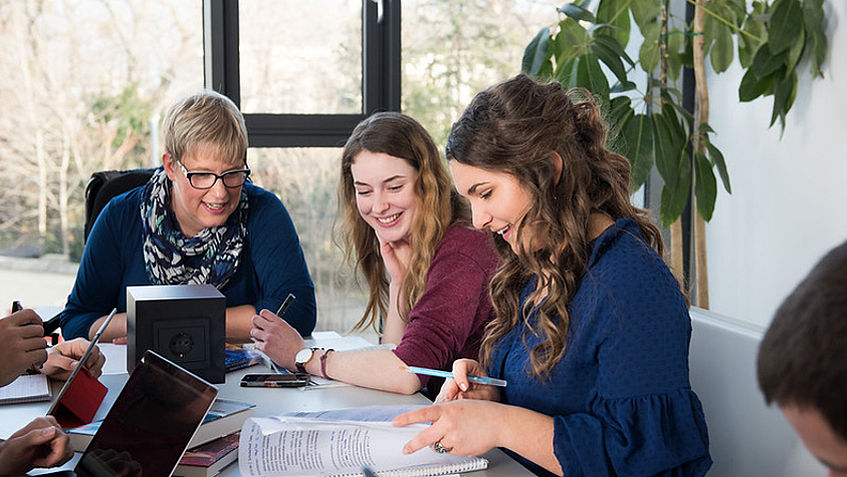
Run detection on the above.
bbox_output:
[74,351,218,477]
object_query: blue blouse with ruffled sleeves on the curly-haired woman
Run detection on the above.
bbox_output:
[488,219,712,477]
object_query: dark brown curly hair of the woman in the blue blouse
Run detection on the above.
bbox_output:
[447,74,664,377]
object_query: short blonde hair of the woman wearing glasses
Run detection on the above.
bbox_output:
[162,90,247,165]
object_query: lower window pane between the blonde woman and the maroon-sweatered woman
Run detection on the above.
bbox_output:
[247,148,367,332]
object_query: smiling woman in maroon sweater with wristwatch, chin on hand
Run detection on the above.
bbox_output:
[252,113,499,395]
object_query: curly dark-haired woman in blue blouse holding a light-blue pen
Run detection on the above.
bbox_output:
[395,75,711,477]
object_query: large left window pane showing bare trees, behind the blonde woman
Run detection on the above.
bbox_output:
[0,0,203,308]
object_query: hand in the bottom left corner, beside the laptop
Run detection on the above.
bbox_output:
[0,416,74,475]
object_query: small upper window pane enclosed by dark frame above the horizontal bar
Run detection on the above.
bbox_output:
[238,0,362,114]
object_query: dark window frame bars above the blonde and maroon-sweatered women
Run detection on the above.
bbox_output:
[203,0,401,147]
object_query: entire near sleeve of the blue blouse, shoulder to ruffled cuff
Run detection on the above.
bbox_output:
[554,218,711,477]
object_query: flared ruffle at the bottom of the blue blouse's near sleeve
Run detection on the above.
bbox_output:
[553,389,711,477]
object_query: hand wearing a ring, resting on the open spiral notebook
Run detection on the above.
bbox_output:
[392,400,504,455]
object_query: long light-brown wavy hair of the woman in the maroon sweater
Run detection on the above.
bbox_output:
[338,112,469,332]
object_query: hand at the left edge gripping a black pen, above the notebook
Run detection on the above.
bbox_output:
[0,308,47,386]
